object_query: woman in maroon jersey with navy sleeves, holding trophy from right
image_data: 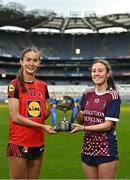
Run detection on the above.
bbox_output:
[71,60,121,179]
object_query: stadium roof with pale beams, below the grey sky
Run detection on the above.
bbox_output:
[0,3,130,33]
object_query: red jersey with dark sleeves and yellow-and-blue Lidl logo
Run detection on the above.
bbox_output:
[8,78,49,147]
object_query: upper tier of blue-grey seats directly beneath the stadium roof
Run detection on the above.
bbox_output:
[0,30,130,60]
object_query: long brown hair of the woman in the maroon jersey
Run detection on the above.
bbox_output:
[92,59,116,90]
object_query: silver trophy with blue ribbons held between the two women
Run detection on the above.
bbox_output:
[52,96,78,132]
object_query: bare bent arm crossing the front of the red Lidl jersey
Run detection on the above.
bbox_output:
[9,98,55,134]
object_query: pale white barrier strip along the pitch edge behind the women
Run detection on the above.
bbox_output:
[0,84,130,102]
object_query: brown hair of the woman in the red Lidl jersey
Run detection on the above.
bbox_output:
[17,47,41,93]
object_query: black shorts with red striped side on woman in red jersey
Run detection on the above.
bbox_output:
[7,143,44,159]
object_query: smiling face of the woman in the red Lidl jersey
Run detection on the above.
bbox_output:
[20,51,40,76]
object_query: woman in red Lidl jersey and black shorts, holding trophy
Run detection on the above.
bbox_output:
[7,47,55,179]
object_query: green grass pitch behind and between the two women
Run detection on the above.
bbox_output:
[0,103,130,179]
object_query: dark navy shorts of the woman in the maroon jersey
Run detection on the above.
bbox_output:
[81,154,119,166]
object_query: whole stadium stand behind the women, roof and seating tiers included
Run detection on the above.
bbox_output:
[0,3,130,99]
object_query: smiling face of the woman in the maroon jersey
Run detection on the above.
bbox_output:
[91,62,110,86]
